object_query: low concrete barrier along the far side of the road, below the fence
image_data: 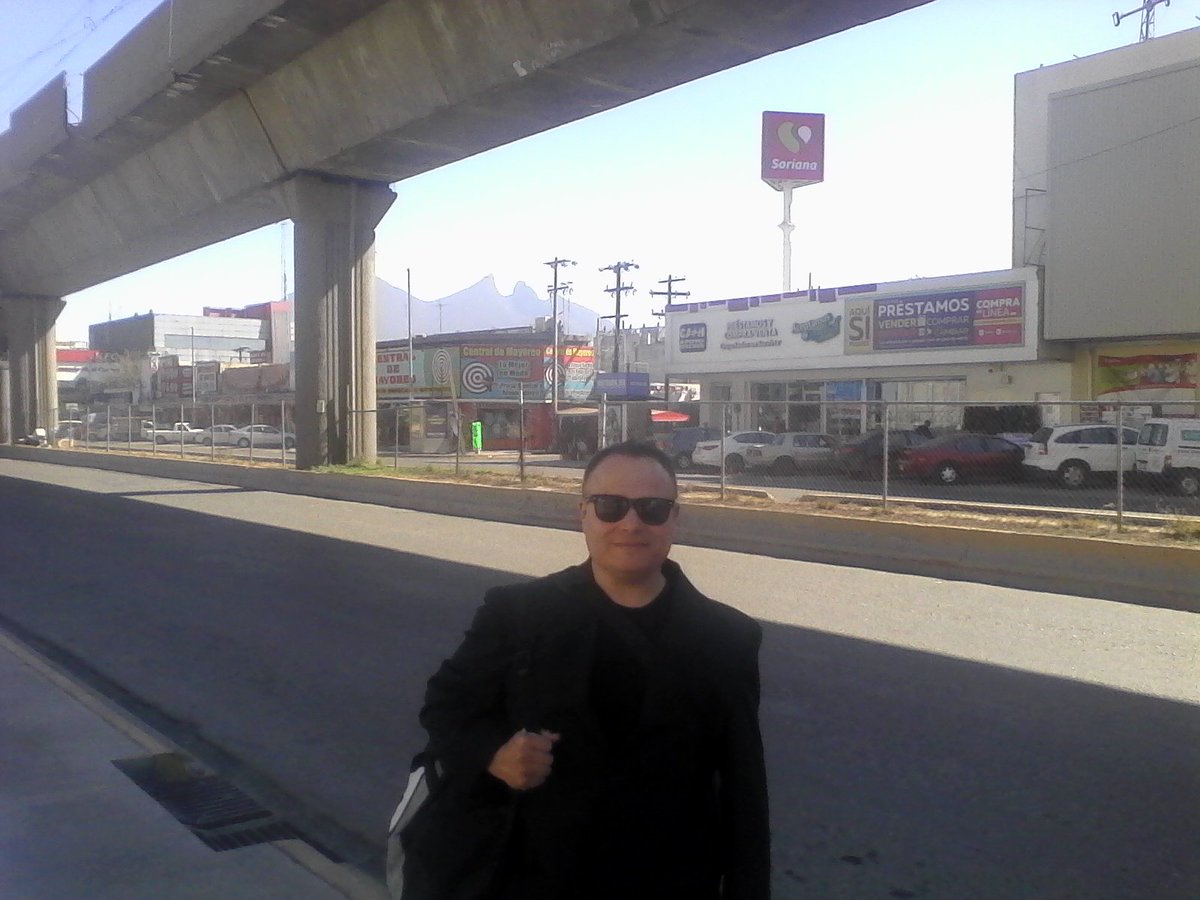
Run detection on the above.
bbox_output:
[0,446,1200,612]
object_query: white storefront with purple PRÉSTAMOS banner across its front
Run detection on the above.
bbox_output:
[666,268,1072,438]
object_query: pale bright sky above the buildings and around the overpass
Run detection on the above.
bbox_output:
[7,0,1200,341]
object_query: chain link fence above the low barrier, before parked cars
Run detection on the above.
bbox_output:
[53,396,1200,524]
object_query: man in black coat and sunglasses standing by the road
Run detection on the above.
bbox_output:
[421,443,770,900]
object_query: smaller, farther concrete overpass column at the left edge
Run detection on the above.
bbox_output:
[0,295,66,440]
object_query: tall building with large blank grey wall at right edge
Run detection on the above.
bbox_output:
[1013,29,1200,414]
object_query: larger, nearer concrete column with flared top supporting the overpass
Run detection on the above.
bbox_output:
[282,174,396,469]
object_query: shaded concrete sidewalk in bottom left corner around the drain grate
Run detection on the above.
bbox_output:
[0,632,386,900]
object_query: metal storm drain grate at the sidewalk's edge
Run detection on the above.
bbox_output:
[113,754,301,851]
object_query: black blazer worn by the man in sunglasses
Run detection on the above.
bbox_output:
[421,562,770,900]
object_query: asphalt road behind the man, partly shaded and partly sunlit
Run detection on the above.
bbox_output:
[0,460,1200,900]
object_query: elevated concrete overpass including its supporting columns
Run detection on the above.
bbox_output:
[0,0,929,468]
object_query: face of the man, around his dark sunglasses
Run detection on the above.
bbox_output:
[580,456,678,581]
